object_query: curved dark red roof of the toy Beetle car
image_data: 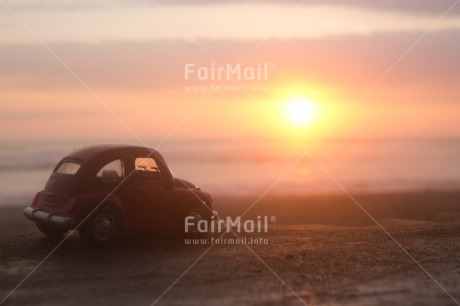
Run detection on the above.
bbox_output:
[64,143,158,162]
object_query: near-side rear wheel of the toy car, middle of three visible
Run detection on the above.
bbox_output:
[79,207,121,246]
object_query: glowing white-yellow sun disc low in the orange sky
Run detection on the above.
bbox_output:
[284,98,318,126]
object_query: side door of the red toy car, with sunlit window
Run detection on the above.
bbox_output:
[131,152,174,227]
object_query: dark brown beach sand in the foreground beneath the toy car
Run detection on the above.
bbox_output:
[0,191,460,305]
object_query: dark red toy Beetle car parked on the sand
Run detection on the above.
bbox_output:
[24,144,217,244]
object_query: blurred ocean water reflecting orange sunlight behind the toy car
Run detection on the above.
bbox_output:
[0,138,460,206]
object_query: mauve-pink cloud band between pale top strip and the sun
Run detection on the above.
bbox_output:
[0,31,460,102]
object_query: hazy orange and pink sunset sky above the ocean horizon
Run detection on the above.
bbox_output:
[0,0,460,141]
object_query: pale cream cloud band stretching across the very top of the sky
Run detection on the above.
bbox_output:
[0,3,460,44]
